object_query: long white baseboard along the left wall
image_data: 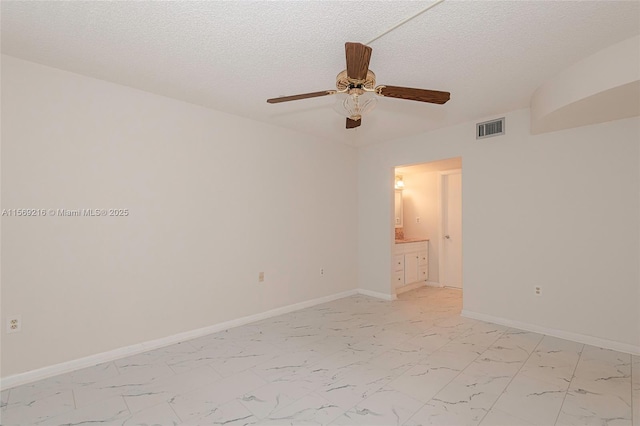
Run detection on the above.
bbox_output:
[0,289,358,390]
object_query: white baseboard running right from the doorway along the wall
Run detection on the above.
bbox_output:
[460,309,640,355]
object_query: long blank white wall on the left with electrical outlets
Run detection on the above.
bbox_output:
[1,56,357,377]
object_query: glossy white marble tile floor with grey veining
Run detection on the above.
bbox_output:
[1,287,640,426]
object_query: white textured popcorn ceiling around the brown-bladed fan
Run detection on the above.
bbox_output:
[1,0,640,146]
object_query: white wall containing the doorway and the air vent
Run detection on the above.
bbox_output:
[358,110,640,351]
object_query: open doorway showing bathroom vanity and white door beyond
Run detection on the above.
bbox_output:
[392,157,463,294]
